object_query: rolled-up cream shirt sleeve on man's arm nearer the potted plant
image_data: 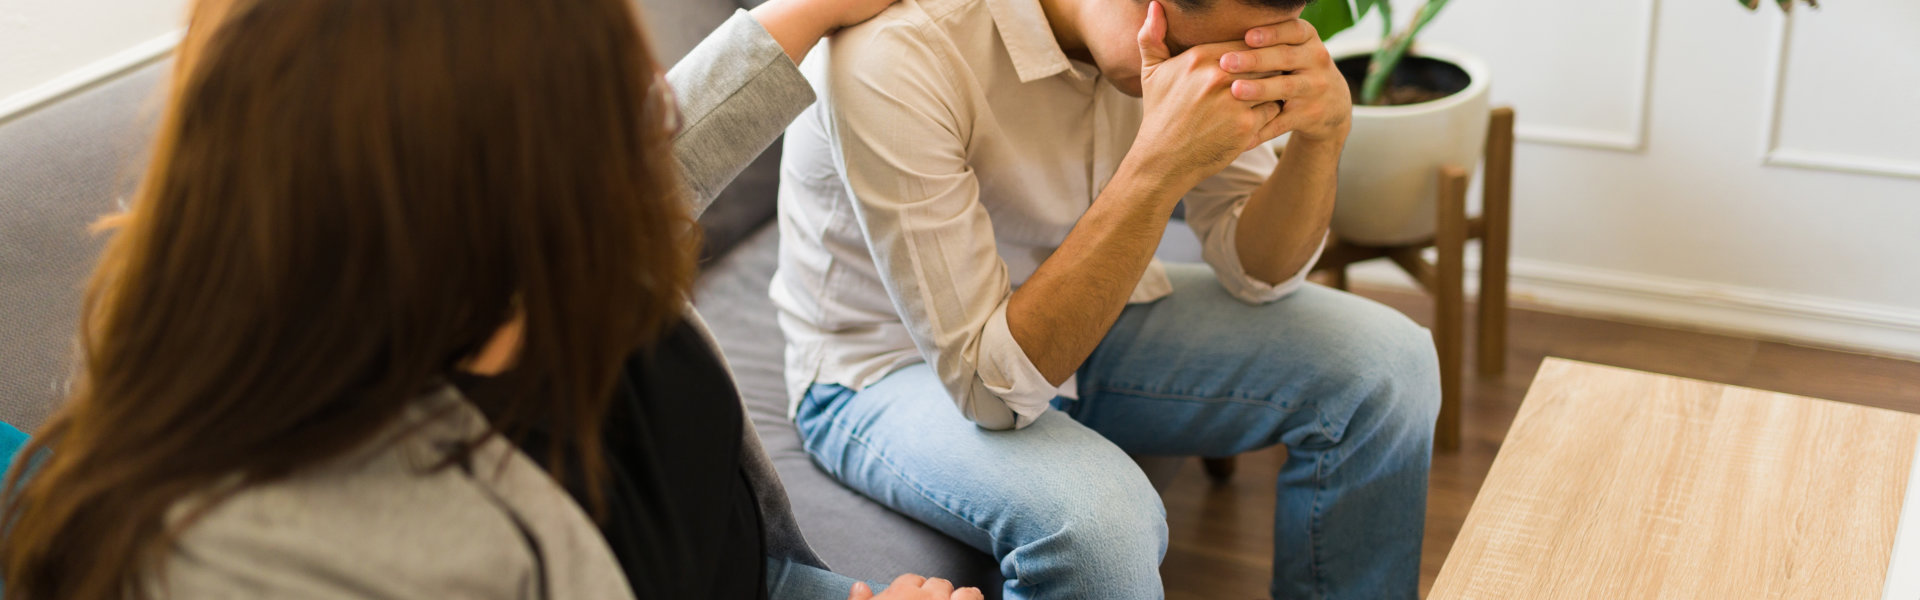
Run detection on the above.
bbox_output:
[1183,144,1327,304]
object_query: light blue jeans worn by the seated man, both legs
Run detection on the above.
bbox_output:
[795,265,1440,598]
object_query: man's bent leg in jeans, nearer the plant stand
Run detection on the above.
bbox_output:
[1066,265,1440,598]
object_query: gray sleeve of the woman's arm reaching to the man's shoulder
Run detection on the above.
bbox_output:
[666,10,814,215]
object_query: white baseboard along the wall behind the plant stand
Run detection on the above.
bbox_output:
[1350,253,1920,360]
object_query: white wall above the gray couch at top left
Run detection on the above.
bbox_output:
[0,0,186,121]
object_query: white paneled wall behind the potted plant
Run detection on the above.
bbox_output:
[1342,0,1920,356]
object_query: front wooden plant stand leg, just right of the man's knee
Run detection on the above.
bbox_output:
[1432,165,1467,452]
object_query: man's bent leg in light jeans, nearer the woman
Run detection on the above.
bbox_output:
[795,365,1167,600]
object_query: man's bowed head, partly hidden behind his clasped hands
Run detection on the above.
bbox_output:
[1073,0,1308,96]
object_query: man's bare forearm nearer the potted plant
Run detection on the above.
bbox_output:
[1235,137,1346,285]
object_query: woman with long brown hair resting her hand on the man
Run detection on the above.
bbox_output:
[0,0,979,600]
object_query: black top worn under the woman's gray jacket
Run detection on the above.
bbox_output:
[461,321,766,600]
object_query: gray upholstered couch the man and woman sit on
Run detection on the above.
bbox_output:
[0,0,1198,596]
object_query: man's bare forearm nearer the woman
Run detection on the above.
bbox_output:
[1006,163,1192,385]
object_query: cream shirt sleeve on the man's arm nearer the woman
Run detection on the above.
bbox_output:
[826,23,1056,429]
